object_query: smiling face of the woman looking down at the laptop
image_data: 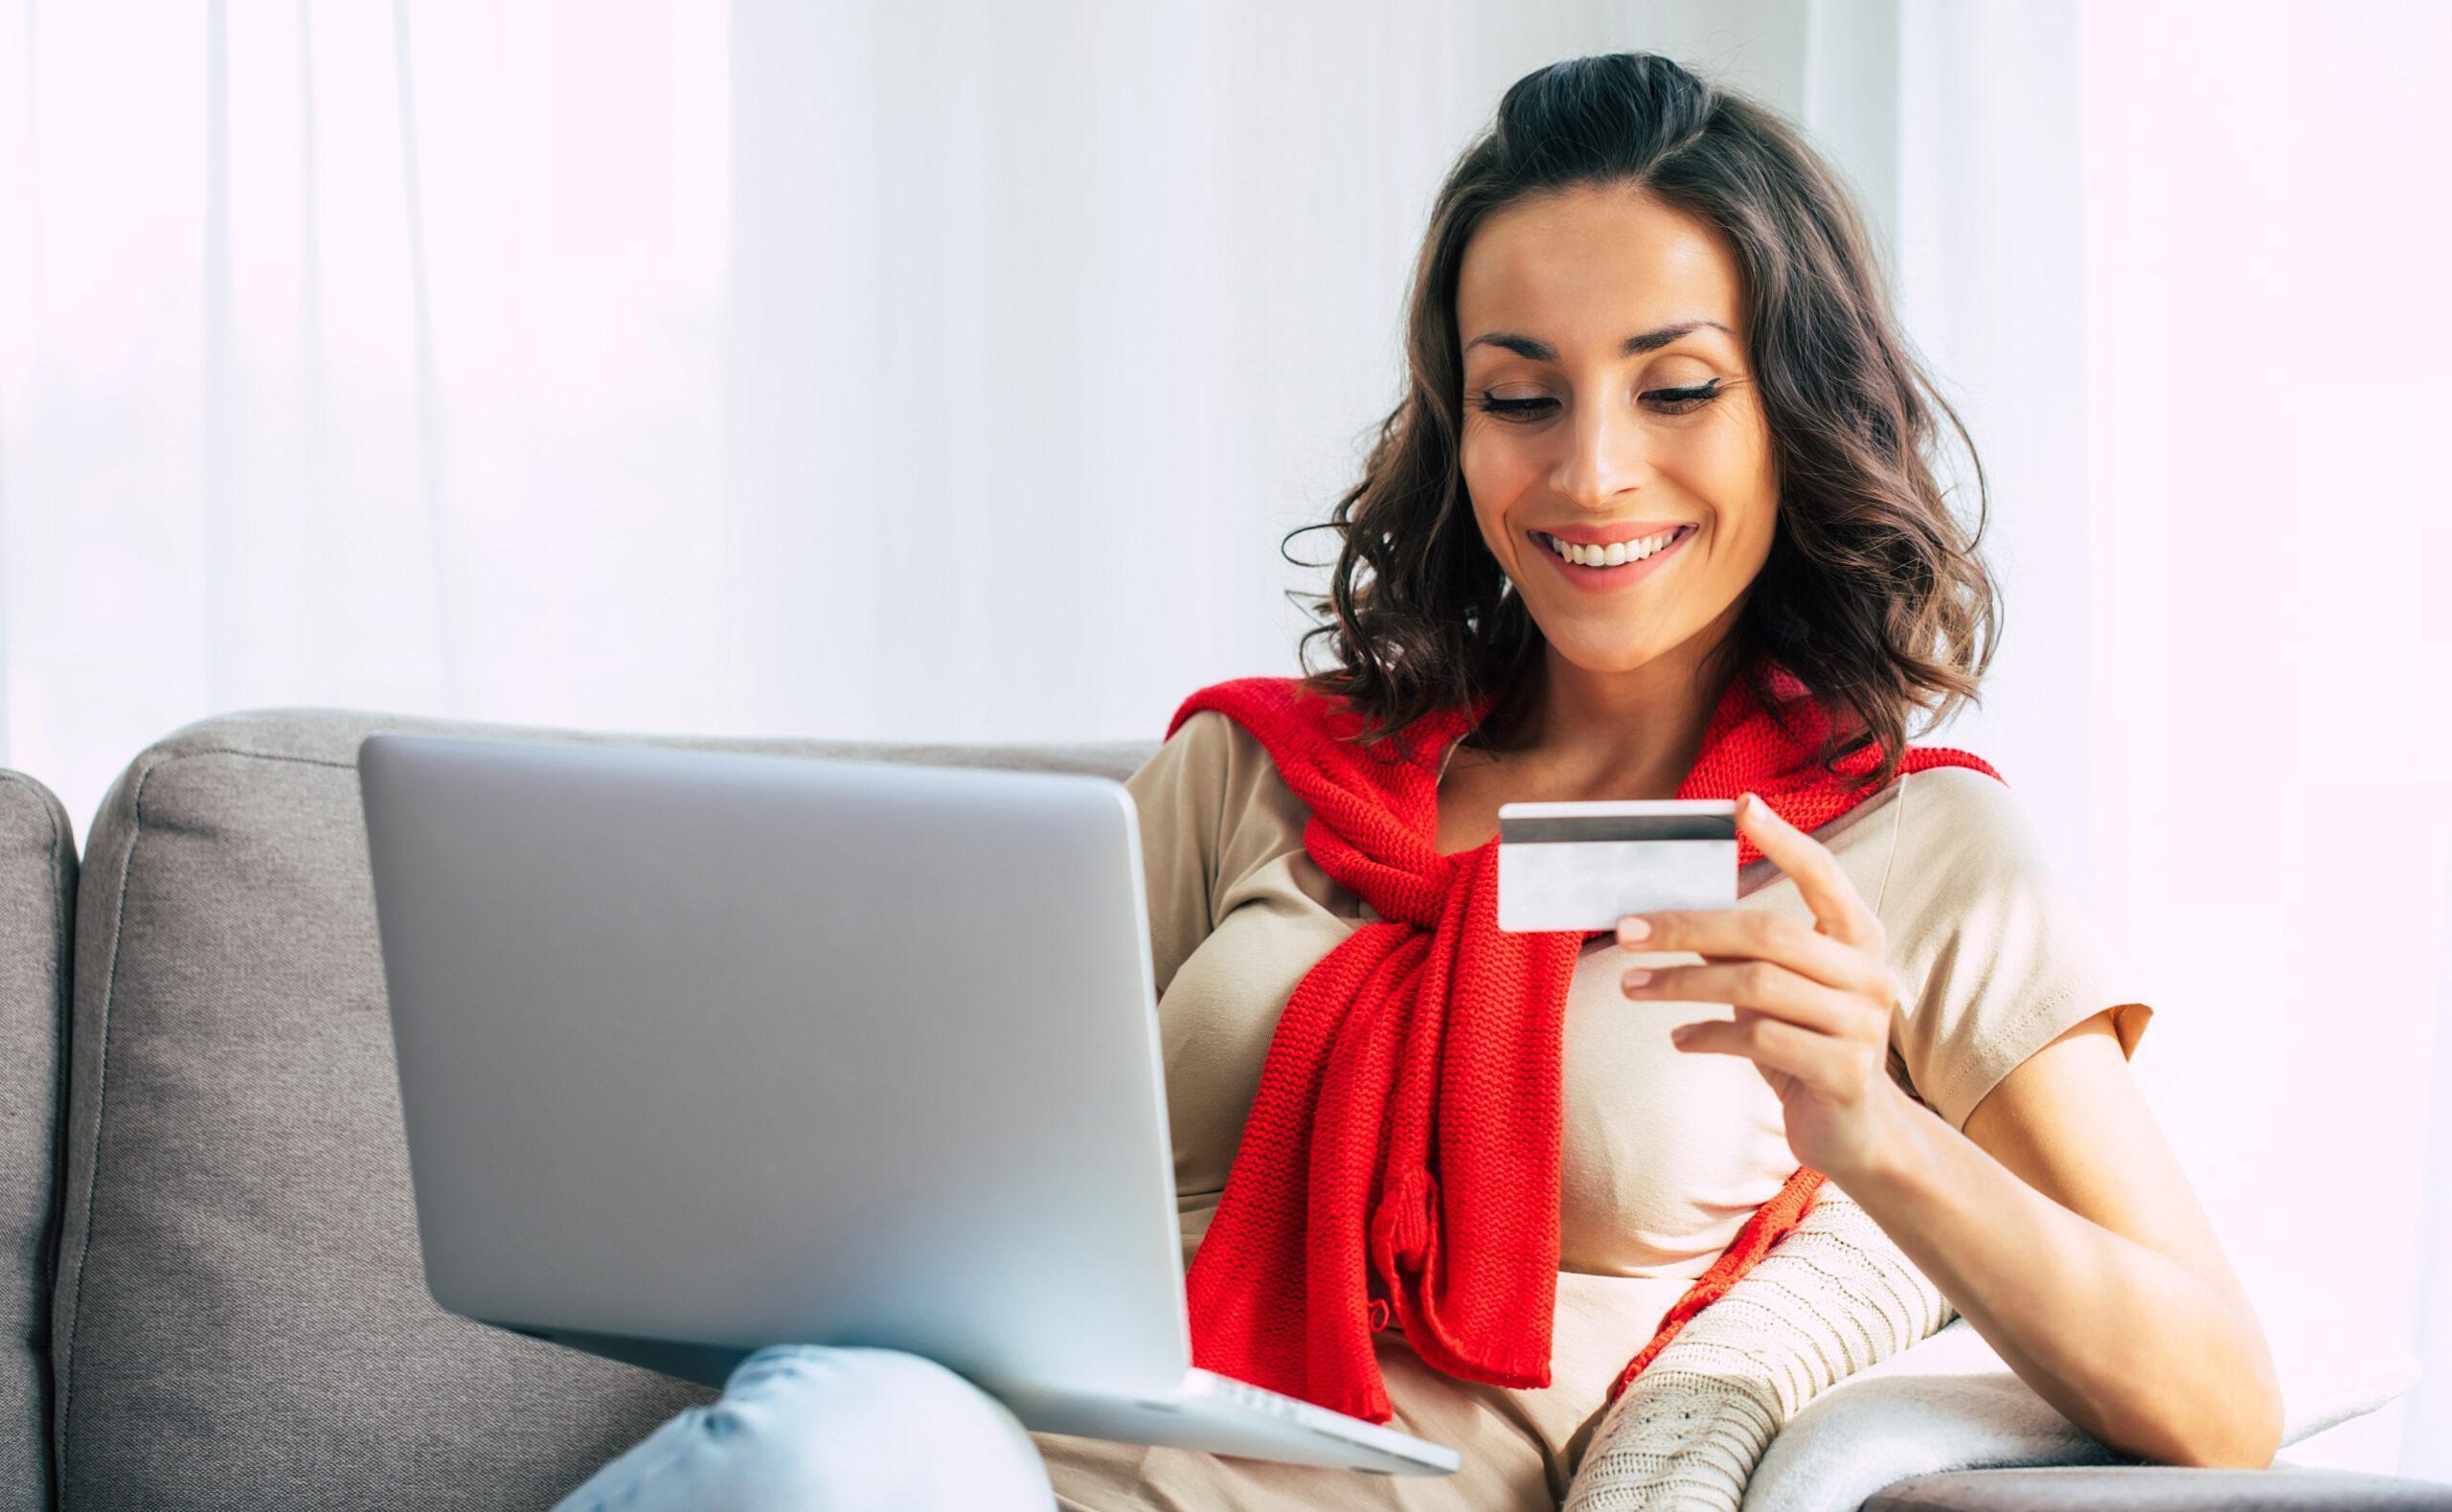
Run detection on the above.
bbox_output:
[1457,186,1781,671]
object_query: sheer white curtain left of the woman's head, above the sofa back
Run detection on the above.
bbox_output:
[0,0,1803,828]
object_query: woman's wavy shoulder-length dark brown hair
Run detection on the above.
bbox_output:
[1280,52,2001,786]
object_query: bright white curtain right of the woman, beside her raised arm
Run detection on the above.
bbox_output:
[1893,0,2452,1480]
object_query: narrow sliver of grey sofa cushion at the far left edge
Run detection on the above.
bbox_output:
[0,772,76,1507]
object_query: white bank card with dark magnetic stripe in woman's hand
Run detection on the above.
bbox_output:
[1498,799,1736,934]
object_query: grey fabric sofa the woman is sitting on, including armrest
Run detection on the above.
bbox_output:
[0,709,2452,1512]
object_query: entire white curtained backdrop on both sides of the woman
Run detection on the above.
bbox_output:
[0,0,2452,1478]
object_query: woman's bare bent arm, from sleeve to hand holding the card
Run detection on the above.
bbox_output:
[1619,801,2282,1468]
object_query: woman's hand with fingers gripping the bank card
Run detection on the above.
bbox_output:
[1619,794,1908,1186]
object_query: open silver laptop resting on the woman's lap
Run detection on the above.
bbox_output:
[358,733,1459,1476]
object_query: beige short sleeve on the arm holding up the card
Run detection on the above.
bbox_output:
[1881,767,2153,1130]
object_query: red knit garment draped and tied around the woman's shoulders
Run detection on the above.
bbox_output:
[1168,665,2001,1424]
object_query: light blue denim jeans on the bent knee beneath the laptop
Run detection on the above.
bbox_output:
[555,1345,1056,1512]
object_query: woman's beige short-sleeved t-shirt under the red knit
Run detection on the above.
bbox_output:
[1037,709,2153,1512]
